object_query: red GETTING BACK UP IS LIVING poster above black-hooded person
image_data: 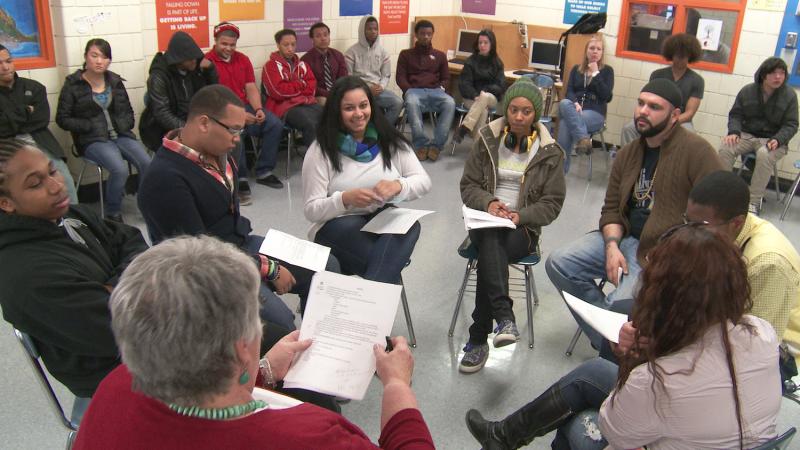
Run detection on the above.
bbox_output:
[156,0,209,51]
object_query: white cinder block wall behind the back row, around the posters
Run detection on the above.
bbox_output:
[15,0,800,179]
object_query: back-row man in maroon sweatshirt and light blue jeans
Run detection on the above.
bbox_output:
[396,20,456,161]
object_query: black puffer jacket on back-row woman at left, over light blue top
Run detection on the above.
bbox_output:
[56,69,136,154]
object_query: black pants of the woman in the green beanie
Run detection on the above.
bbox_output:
[469,227,536,345]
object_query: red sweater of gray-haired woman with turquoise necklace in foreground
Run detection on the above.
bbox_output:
[73,365,434,450]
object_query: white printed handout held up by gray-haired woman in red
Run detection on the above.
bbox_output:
[283,272,402,400]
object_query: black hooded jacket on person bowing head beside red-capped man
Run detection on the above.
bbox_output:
[139,31,219,151]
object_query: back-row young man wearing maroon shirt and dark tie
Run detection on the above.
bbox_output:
[300,22,348,106]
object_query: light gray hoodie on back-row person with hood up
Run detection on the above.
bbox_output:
[344,16,392,89]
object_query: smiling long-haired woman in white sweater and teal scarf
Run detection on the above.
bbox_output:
[303,76,431,284]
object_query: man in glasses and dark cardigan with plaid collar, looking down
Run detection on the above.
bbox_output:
[138,84,339,330]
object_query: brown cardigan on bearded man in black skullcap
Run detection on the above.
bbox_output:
[600,126,722,264]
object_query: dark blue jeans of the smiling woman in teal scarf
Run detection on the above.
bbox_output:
[314,211,421,284]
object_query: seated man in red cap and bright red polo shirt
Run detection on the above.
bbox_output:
[206,22,283,197]
